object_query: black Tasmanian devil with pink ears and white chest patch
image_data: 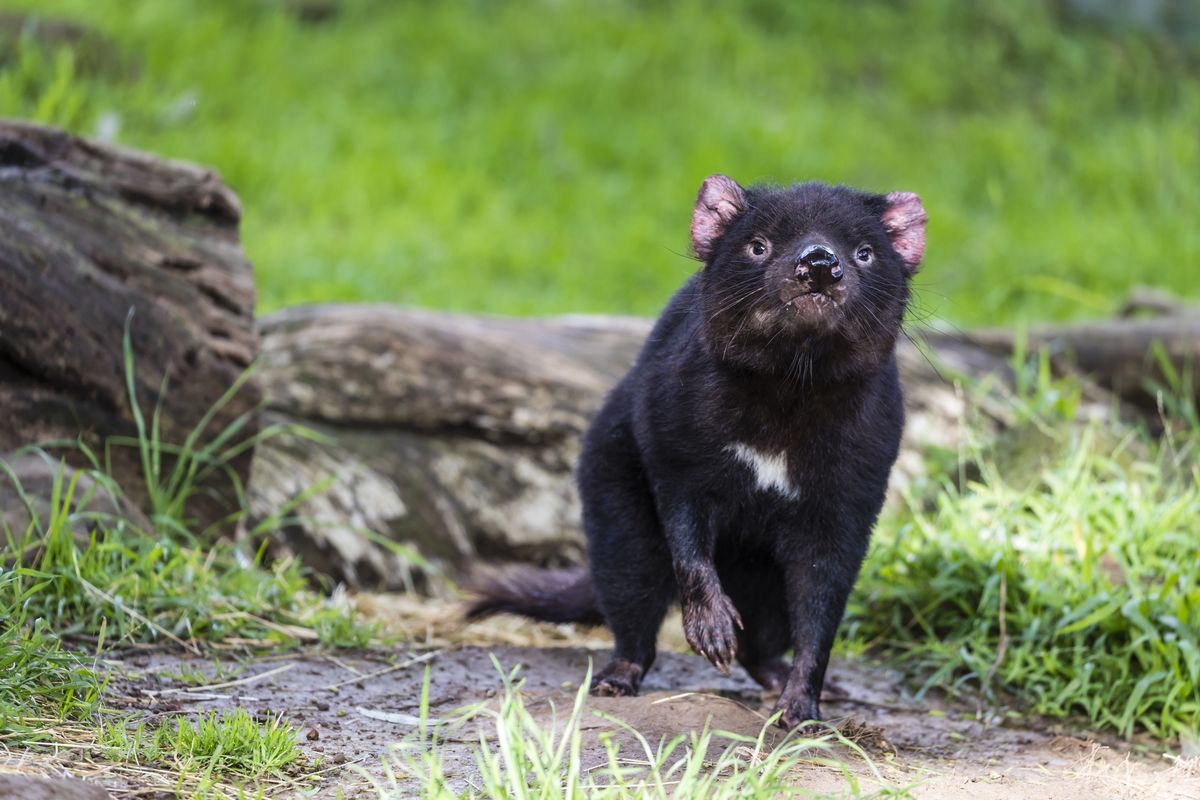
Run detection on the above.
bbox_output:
[468,175,925,727]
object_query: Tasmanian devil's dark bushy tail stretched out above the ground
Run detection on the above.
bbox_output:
[467,566,604,625]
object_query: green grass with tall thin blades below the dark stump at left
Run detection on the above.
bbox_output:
[0,314,374,762]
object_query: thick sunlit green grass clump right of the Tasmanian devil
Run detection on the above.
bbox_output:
[844,359,1200,739]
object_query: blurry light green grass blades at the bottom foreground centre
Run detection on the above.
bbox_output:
[378,660,908,800]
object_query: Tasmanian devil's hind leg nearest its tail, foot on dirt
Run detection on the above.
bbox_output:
[580,412,676,696]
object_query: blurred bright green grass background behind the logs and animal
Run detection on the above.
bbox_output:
[0,0,1200,325]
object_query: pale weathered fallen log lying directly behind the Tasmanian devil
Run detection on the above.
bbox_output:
[248,306,1022,588]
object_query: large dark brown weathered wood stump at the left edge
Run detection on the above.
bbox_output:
[0,121,260,529]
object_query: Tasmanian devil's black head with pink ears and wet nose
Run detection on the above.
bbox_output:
[691,175,925,376]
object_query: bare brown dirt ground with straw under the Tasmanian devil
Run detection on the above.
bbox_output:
[0,597,1200,800]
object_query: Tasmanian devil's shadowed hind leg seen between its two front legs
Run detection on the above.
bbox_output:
[718,559,791,693]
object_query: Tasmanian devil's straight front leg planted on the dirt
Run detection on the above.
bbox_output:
[774,537,865,728]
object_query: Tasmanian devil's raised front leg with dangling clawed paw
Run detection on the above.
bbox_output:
[664,503,742,673]
